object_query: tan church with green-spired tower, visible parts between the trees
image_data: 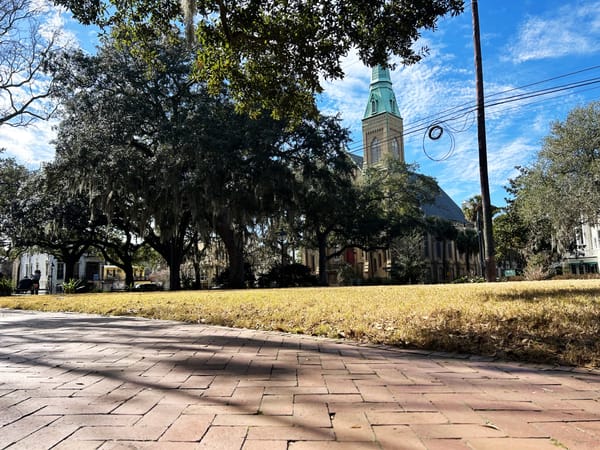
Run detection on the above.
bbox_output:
[303,66,478,285]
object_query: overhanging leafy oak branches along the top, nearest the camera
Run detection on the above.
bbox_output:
[54,0,463,123]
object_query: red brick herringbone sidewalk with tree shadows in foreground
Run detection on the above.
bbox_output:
[0,310,600,450]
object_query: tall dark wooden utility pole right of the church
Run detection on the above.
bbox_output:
[471,0,496,281]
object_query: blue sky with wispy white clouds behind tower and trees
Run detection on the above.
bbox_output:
[0,0,600,206]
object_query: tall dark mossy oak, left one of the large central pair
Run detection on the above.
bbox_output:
[55,43,215,289]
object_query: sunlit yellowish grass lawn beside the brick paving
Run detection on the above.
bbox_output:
[0,280,600,367]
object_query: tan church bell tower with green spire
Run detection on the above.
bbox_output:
[362,66,404,166]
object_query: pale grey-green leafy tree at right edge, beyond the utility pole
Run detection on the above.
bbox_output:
[511,102,600,255]
